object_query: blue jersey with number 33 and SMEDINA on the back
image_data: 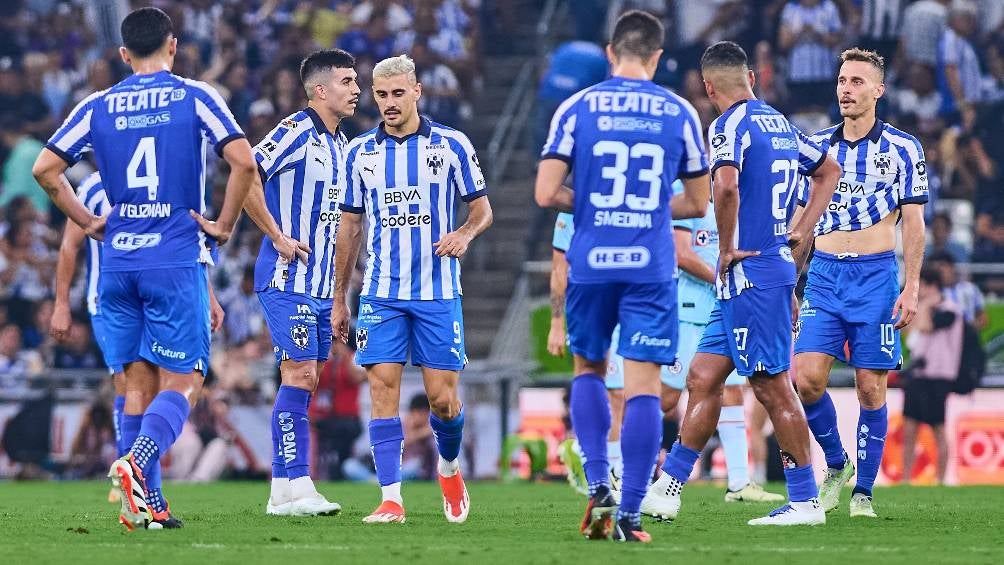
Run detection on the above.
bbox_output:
[541,77,708,283]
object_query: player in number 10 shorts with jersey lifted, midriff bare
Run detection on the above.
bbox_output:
[795,49,928,518]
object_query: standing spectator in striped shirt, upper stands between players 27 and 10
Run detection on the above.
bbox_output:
[778,0,841,111]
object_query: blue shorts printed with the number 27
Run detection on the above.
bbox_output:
[697,285,794,377]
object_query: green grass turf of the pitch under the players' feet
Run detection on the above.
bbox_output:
[0,483,1004,565]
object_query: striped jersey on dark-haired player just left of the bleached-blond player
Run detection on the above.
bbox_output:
[254,107,348,298]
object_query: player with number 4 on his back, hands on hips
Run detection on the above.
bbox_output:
[33,8,257,530]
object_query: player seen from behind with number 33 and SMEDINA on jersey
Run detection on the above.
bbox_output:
[535,10,709,542]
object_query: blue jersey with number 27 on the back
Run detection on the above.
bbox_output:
[708,99,826,299]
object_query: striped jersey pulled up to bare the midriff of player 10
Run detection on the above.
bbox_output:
[798,119,928,236]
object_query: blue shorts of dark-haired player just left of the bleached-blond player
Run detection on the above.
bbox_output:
[258,288,331,364]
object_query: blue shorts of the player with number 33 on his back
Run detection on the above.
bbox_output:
[565,281,678,365]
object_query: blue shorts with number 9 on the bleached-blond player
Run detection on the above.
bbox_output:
[355,296,467,371]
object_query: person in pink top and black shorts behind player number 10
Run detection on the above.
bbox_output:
[903,267,963,484]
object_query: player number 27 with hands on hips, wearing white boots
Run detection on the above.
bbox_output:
[647,41,840,525]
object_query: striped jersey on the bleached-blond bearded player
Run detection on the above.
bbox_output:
[340,117,487,300]
